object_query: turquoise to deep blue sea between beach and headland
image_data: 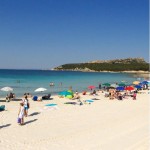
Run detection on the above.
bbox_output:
[0,69,144,97]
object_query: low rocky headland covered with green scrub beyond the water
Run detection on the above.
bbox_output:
[54,58,149,72]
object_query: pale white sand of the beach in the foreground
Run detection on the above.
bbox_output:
[0,93,150,150]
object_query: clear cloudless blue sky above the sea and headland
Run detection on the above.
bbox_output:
[0,0,149,69]
